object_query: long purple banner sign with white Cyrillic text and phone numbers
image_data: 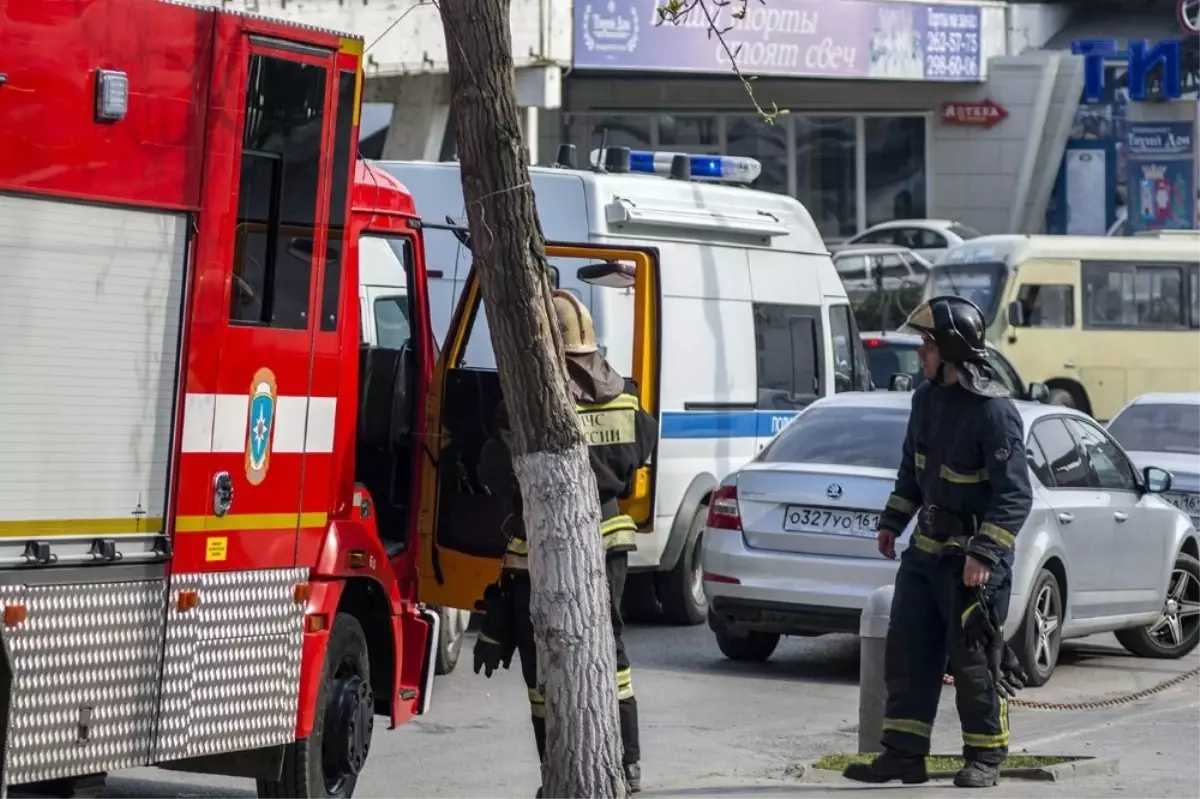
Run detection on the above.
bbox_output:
[574,0,985,83]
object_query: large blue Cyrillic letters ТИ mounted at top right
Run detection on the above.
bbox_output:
[1070,40,1183,103]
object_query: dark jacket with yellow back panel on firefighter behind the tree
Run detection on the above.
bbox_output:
[484,353,658,570]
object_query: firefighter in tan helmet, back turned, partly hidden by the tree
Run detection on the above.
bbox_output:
[475,290,659,797]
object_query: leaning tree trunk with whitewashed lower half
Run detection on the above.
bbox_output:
[440,0,624,799]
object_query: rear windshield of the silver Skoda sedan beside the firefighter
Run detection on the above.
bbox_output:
[758,407,908,469]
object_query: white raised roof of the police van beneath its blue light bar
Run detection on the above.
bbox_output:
[378,153,828,254]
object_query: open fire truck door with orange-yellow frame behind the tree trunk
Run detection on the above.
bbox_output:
[416,244,660,609]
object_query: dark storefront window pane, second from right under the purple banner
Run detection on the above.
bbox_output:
[792,116,858,241]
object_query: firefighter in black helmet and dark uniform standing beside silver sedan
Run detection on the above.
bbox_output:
[844,296,1032,788]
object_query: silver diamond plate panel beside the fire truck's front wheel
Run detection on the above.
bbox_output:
[154,569,308,763]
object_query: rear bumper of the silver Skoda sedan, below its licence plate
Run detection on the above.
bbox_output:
[702,528,896,635]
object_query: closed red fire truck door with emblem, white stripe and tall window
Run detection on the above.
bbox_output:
[176,36,356,570]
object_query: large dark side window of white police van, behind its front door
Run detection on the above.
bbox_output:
[754,302,822,410]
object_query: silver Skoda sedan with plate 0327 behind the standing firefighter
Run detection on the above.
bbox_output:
[702,391,1200,685]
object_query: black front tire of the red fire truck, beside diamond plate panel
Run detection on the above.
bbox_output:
[258,613,374,799]
